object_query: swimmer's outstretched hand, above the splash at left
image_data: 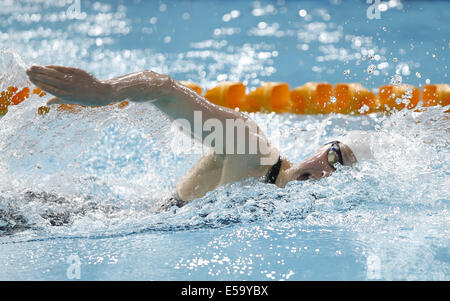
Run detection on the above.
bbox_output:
[27,65,112,106]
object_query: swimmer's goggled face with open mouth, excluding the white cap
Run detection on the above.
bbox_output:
[295,142,356,181]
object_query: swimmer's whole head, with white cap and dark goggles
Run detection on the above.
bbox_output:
[294,131,373,181]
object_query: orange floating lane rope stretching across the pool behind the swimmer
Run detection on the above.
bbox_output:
[0,81,450,116]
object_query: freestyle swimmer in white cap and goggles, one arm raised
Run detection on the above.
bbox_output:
[27,65,372,209]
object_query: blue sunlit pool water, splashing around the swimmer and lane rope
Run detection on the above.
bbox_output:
[0,0,450,280]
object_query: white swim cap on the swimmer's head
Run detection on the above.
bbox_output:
[337,131,374,161]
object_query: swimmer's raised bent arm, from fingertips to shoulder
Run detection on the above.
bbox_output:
[27,65,270,158]
